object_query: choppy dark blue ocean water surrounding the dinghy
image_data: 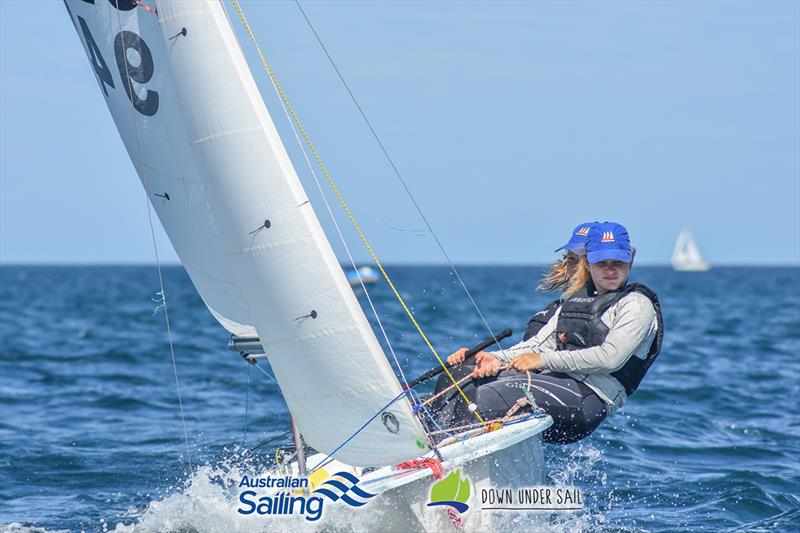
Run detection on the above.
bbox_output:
[0,266,800,531]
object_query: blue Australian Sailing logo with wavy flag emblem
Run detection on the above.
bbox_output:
[237,472,375,522]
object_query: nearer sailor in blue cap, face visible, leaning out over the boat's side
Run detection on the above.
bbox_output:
[444,222,664,444]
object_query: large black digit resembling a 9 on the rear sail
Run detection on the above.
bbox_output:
[112,30,158,117]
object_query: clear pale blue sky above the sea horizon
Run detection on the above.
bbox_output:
[0,0,800,264]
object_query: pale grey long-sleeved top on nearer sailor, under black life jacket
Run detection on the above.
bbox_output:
[490,292,658,414]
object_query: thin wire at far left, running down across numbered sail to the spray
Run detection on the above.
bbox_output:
[106,6,193,471]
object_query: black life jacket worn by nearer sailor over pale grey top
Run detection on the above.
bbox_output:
[556,283,664,395]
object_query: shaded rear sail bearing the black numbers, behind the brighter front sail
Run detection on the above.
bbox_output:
[66,0,255,336]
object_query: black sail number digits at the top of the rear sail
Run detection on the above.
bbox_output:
[70,0,158,117]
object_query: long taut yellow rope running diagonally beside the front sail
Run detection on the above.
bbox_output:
[231,0,486,427]
